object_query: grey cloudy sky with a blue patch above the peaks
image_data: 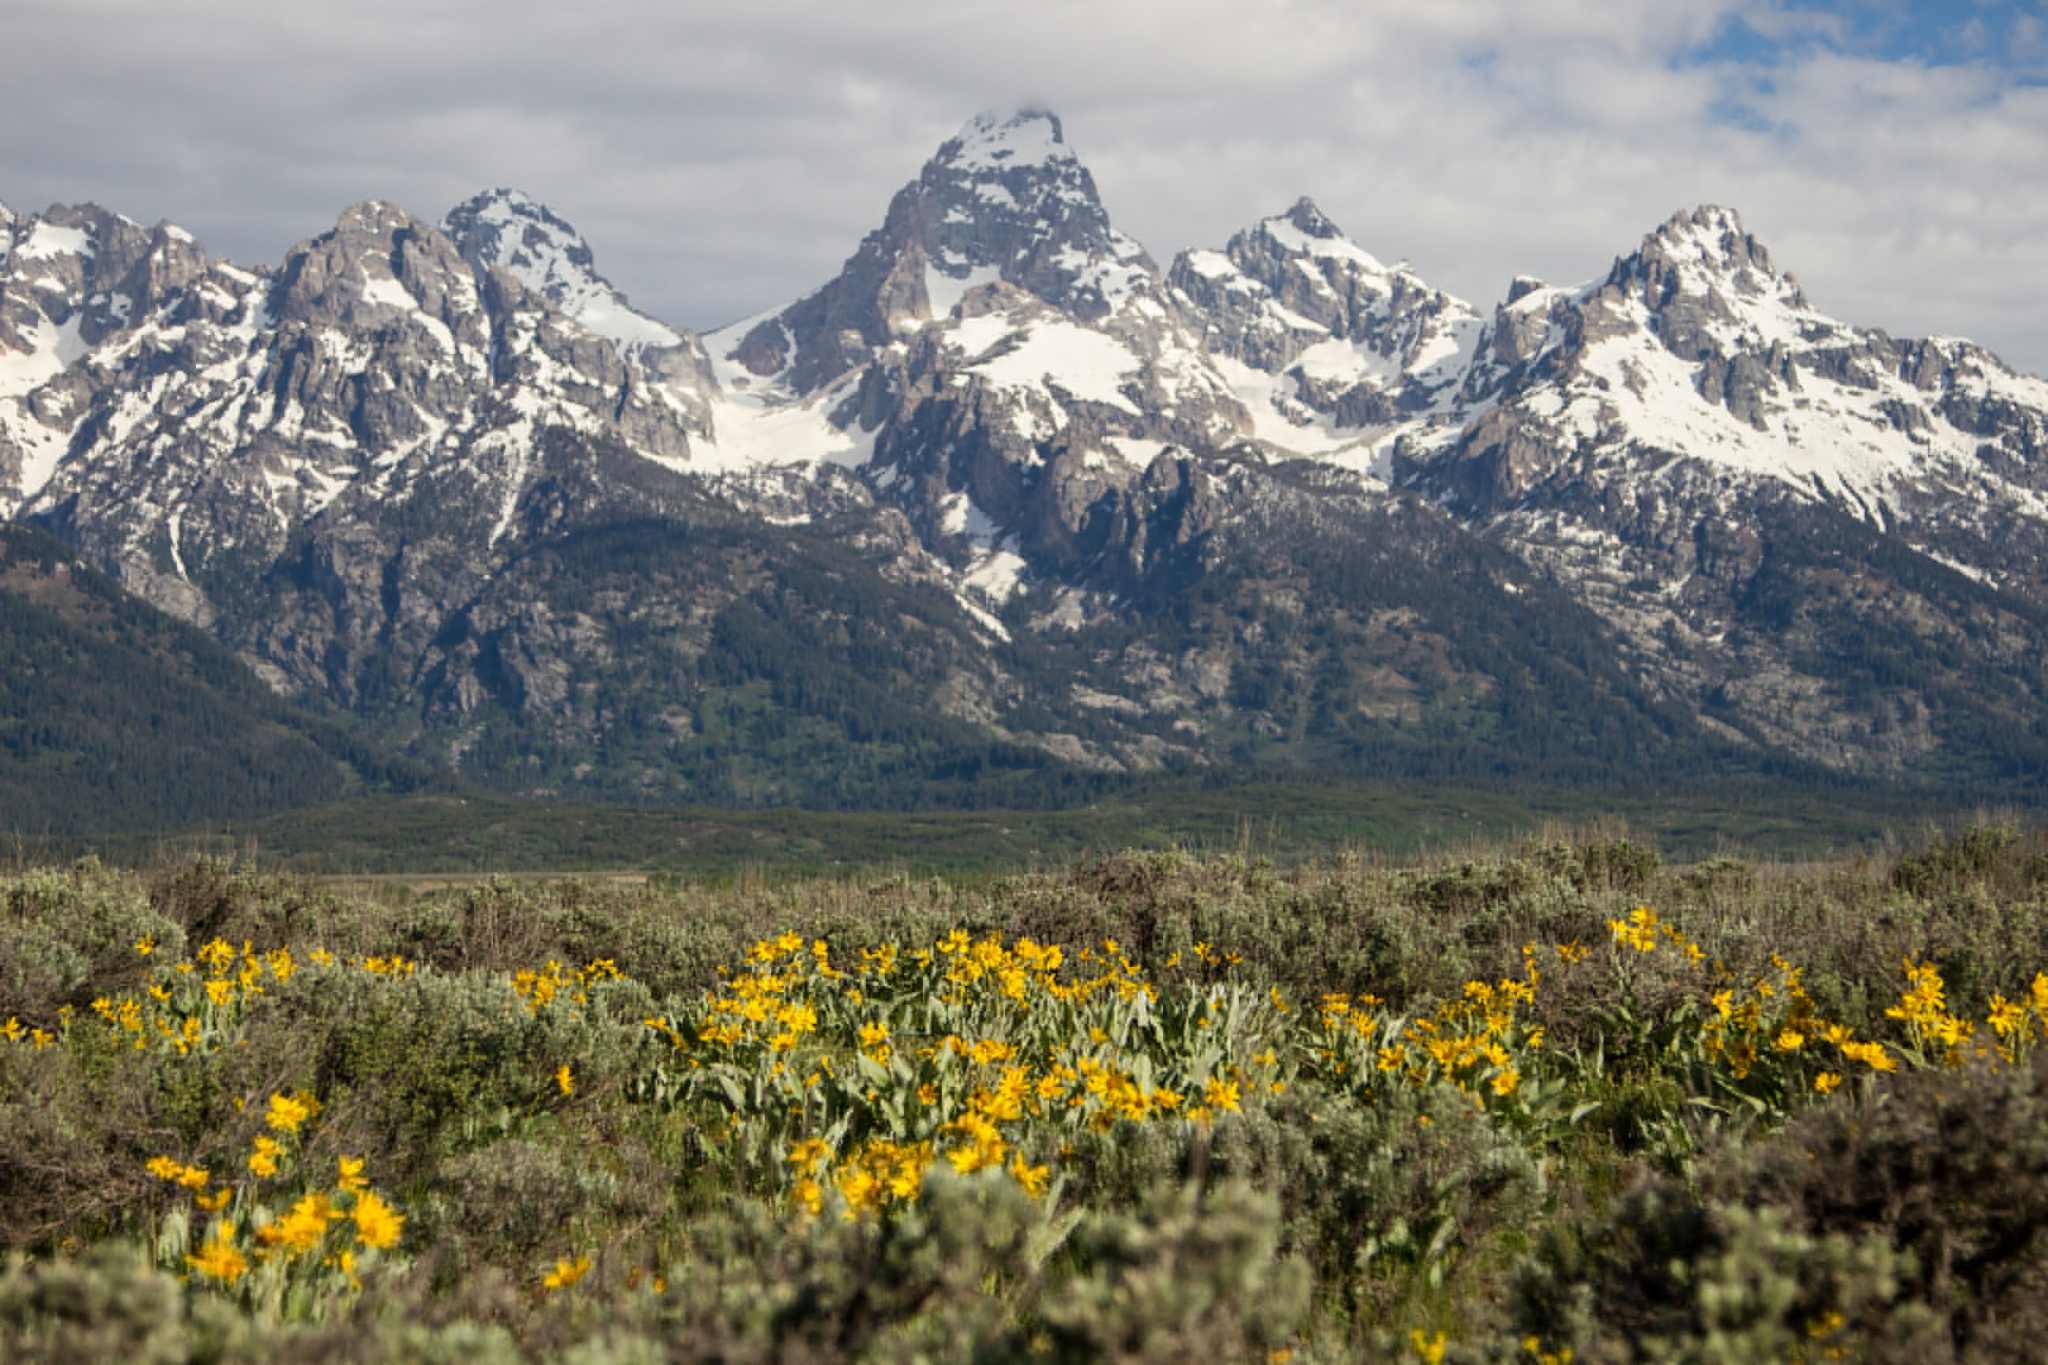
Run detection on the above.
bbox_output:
[12,0,2048,372]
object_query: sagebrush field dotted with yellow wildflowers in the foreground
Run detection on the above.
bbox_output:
[0,829,2048,1365]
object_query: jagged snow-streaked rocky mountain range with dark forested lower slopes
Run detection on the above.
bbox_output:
[0,111,2048,806]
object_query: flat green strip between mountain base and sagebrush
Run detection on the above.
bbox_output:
[48,784,2025,878]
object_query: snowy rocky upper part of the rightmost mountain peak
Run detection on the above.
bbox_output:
[1421,205,2048,556]
